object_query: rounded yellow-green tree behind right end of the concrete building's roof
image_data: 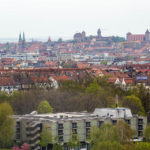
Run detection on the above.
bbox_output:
[122,95,145,115]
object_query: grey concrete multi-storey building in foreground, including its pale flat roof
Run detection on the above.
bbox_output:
[14,108,147,150]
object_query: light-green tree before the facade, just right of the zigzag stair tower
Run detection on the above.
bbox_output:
[39,125,53,147]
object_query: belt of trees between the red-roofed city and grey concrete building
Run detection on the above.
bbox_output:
[0,77,150,150]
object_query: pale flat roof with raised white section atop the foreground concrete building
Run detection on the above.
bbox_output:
[14,108,132,122]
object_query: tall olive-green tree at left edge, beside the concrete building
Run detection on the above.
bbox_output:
[0,102,14,147]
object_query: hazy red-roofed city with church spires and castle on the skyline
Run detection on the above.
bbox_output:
[0,29,150,93]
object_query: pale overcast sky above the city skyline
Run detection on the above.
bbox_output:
[0,0,150,39]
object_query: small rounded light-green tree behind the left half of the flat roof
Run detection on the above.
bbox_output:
[37,100,53,114]
